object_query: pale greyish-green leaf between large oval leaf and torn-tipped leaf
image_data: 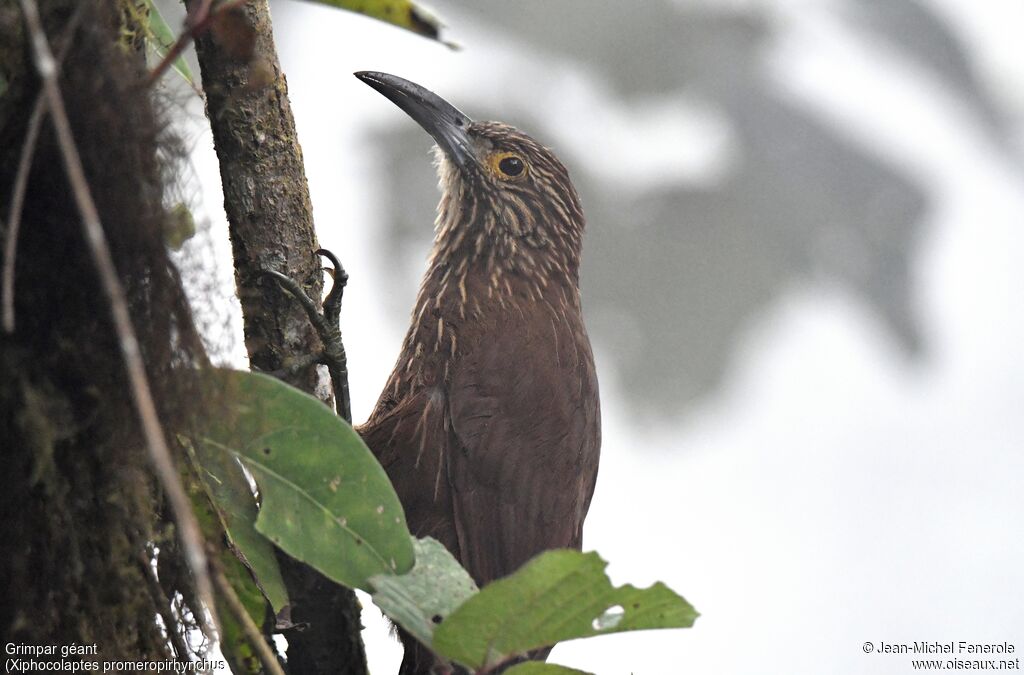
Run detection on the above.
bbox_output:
[370,537,477,647]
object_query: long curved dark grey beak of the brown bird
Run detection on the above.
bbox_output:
[355,71,476,171]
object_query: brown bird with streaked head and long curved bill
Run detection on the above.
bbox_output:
[355,71,601,675]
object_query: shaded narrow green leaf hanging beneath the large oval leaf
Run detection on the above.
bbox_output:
[187,444,288,614]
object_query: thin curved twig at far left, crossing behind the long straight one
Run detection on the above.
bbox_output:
[0,3,85,333]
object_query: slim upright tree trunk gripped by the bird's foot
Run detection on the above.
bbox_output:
[185,0,367,675]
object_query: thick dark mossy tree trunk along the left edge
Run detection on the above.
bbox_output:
[0,0,204,661]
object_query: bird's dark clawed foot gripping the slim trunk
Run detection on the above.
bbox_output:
[262,249,352,422]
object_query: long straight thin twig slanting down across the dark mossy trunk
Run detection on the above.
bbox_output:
[19,0,216,639]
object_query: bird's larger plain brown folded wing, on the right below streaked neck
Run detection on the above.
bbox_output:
[444,309,600,583]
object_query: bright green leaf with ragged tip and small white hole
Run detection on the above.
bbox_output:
[433,550,697,668]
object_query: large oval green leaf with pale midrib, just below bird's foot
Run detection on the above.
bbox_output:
[186,369,414,590]
